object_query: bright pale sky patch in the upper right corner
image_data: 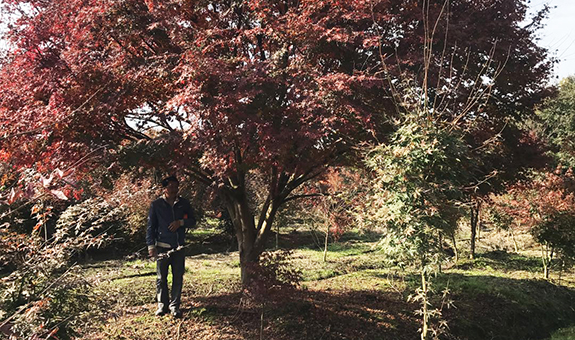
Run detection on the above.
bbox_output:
[530,0,575,80]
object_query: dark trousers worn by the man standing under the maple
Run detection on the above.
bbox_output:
[156,247,185,311]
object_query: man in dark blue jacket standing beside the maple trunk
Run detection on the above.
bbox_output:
[146,176,196,318]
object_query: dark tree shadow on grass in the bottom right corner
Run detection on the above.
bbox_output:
[434,273,575,340]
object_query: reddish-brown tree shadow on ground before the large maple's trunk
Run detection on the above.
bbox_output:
[190,291,418,340]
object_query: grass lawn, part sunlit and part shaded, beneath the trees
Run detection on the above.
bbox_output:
[6,227,575,340]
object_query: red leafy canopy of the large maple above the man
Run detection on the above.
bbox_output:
[0,1,392,181]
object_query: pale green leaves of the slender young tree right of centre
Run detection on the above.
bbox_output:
[366,115,473,265]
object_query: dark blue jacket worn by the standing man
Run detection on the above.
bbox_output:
[146,197,196,248]
